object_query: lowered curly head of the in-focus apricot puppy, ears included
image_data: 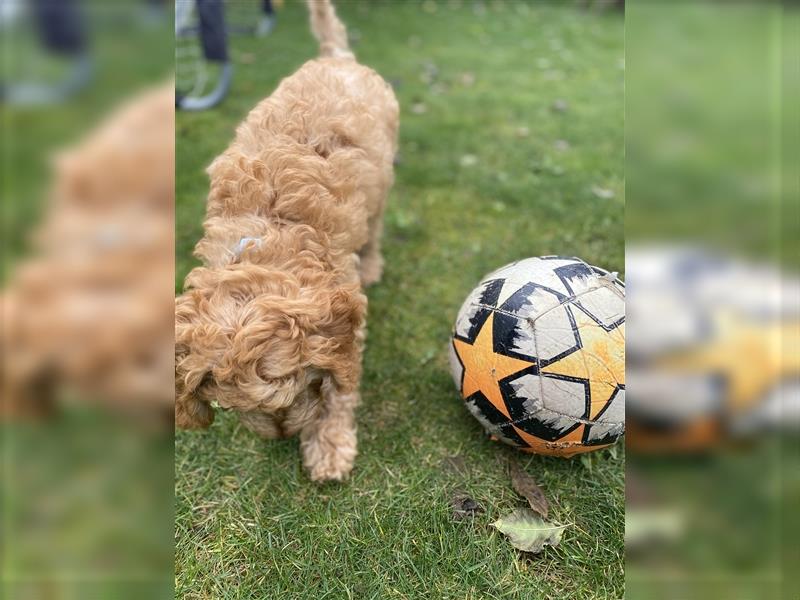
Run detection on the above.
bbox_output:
[175,264,366,437]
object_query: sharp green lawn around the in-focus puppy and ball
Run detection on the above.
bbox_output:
[175,1,624,599]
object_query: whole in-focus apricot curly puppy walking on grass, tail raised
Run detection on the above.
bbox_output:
[175,0,398,481]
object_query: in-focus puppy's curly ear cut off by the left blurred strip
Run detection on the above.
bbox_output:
[175,295,214,429]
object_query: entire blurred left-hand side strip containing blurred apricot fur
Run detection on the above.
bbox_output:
[0,0,174,598]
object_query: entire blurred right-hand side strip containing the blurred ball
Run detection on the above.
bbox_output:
[626,0,800,600]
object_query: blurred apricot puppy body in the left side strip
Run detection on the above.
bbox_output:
[0,84,174,417]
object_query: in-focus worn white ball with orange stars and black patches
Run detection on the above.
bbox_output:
[450,256,625,456]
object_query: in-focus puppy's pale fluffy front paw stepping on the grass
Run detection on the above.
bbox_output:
[300,384,358,481]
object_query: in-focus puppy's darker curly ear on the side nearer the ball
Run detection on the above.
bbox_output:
[306,286,367,393]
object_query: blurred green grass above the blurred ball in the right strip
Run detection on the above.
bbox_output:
[625,1,800,269]
